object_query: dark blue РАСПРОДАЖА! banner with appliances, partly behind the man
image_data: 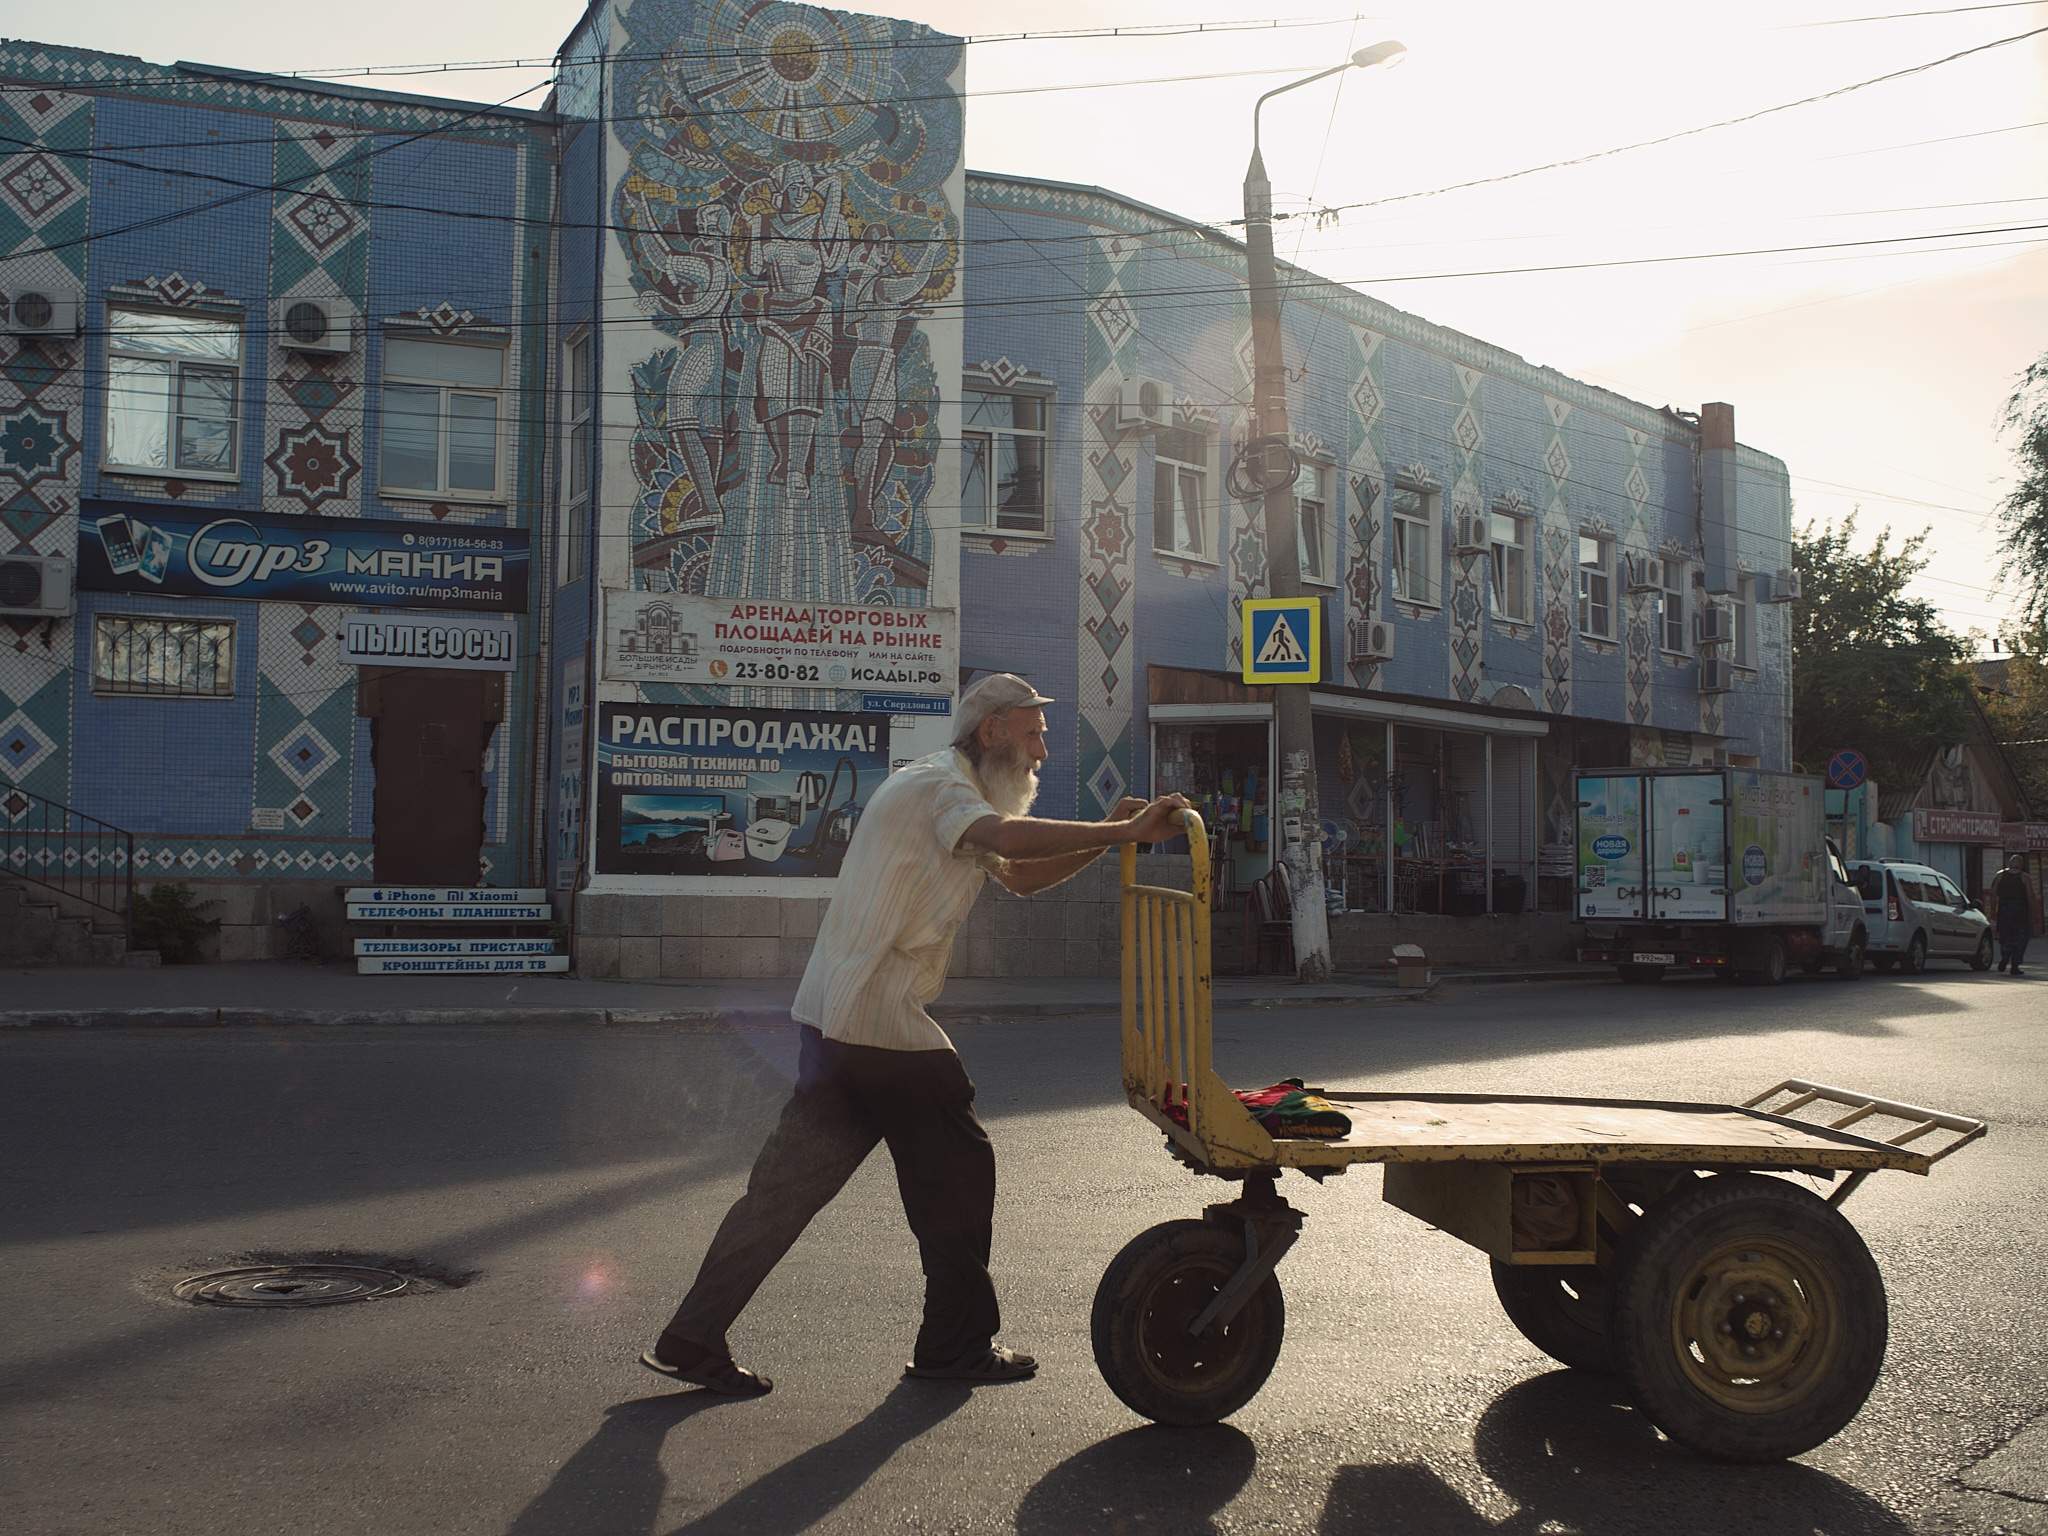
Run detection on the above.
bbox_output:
[596,705,889,879]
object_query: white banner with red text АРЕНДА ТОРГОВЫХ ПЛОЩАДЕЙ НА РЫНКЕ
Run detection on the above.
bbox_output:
[604,592,961,694]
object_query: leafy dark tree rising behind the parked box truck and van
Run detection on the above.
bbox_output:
[1792,512,1970,788]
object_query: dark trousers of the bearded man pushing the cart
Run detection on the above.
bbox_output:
[664,1026,1001,1366]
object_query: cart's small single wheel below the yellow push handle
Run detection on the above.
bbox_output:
[1087,1221,1286,1423]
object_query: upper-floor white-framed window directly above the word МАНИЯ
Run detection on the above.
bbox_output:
[381,336,506,502]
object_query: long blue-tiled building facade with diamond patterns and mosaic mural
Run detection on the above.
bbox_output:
[0,0,1790,975]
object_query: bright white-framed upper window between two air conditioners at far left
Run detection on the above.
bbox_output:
[106,309,242,479]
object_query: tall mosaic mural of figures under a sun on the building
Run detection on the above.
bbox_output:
[610,0,963,606]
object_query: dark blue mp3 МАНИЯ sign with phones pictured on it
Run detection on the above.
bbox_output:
[78,502,530,612]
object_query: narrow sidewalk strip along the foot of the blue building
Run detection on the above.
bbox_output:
[0,961,1610,1028]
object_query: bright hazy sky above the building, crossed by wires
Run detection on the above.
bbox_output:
[28,0,2048,631]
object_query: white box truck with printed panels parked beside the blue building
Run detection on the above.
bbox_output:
[1577,768,1868,983]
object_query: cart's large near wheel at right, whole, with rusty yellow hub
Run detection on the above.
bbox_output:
[1610,1174,1886,1462]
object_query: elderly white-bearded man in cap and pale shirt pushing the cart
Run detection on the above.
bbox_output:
[641,672,1188,1397]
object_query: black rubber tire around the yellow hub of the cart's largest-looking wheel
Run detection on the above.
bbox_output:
[1608,1174,1888,1462]
